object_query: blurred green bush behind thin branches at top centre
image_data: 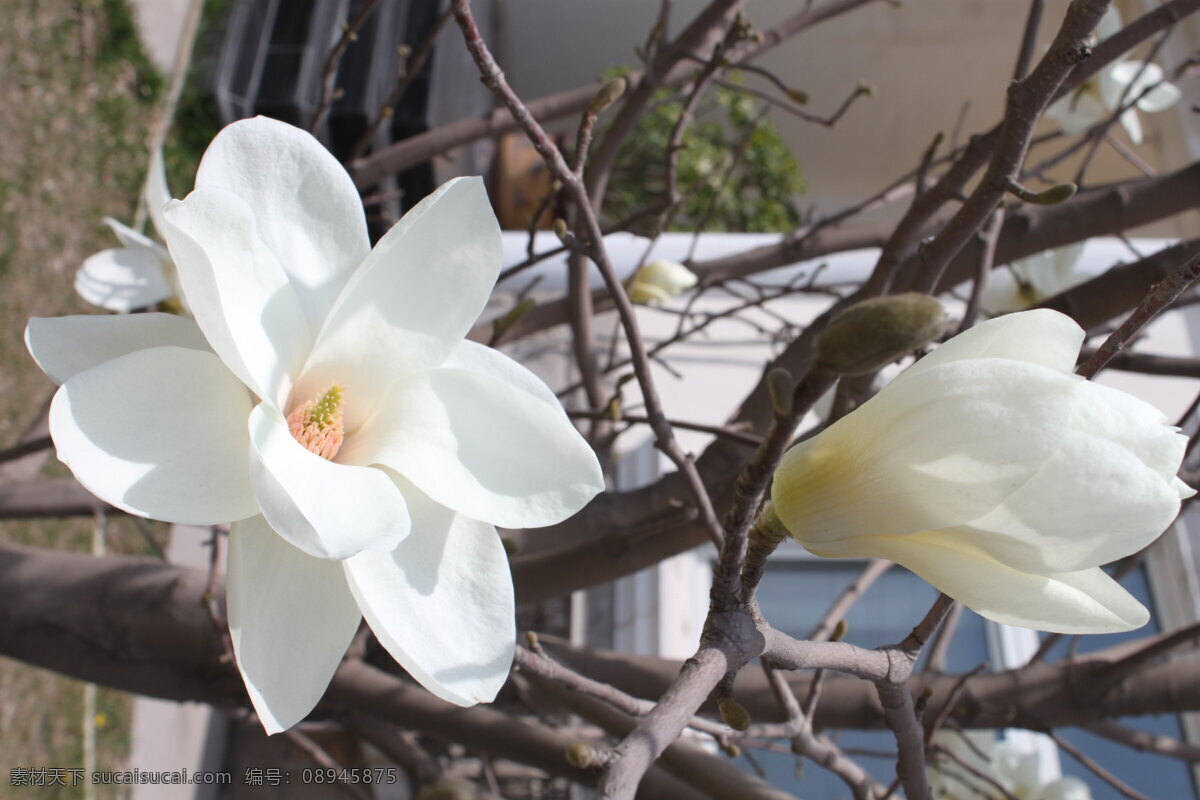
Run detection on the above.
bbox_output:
[605,70,804,233]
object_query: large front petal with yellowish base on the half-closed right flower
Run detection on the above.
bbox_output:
[772,362,1085,545]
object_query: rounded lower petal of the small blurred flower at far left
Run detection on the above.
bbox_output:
[74,246,175,312]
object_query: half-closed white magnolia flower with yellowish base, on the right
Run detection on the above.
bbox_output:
[772,309,1194,633]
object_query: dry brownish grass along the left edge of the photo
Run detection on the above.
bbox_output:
[0,0,160,798]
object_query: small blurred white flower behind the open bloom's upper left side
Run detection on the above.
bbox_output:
[74,150,179,312]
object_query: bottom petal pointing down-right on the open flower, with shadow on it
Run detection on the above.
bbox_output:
[344,486,516,705]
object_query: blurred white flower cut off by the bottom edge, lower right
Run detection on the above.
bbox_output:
[926,730,1092,800]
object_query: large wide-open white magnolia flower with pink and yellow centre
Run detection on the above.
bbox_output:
[26,119,604,733]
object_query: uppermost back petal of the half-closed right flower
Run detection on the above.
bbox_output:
[884,308,1084,383]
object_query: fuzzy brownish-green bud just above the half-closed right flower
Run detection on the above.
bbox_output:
[817,293,946,375]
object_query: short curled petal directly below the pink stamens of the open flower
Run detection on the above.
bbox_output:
[250,403,410,559]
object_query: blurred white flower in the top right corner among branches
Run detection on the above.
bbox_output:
[1046,6,1181,144]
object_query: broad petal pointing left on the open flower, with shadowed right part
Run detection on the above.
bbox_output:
[50,347,258,525]
